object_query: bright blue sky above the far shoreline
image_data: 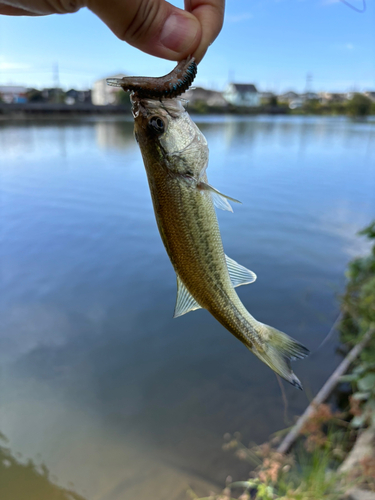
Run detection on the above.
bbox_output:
[0,0,375,92]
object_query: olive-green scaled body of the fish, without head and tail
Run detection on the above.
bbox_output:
[147,160,253,344]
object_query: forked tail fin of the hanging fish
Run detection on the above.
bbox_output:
[251,323,309,390]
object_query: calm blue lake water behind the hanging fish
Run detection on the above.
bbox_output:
[0,116,375,500]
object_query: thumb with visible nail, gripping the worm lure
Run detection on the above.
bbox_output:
[87,0,202,61]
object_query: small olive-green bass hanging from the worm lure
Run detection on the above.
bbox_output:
[111,57,309,390]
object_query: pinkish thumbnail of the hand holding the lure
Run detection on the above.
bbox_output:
[160,14,199,52]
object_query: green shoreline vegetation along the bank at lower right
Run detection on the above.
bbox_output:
[192,221,375,500]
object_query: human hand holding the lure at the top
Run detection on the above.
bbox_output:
[0,0,225,62]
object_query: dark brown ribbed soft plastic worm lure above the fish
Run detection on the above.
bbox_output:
[107,57,197,99]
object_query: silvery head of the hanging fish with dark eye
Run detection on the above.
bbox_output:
[132,96,208,181]
